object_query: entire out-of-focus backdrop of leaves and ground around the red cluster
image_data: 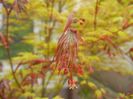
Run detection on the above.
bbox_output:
[0,0,133,99]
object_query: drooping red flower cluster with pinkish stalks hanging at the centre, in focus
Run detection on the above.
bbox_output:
[54,13,82,89]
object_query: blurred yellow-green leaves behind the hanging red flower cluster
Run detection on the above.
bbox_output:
[0,0,133,99]
